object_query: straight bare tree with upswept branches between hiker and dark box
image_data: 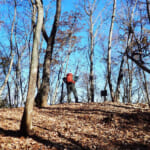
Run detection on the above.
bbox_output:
[84,0,101,102]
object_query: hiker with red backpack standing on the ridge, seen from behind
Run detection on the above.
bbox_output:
[63,73,78,103]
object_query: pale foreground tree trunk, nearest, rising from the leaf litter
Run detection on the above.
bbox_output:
[20,0,43,136]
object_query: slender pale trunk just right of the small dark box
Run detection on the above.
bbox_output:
[107,0,116,102]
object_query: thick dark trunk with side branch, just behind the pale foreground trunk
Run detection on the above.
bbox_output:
[36,0,61,107]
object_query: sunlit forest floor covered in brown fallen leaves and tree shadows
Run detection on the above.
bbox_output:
[0,102,150,150]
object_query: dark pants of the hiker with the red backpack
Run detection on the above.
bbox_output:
[67,83,78,103]
